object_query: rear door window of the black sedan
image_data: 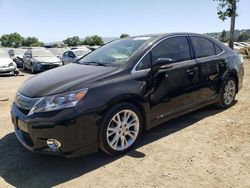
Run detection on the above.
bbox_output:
[190,37,215,58]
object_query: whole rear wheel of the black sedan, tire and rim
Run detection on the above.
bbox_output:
[217,77,237,109]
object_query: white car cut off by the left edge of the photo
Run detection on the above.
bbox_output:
[0,49,19,75]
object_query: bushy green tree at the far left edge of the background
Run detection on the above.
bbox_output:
[0,32,24,48]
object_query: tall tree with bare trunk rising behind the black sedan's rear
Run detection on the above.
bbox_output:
[214,0,239,49]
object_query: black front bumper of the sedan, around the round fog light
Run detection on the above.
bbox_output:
[11,103,98,157]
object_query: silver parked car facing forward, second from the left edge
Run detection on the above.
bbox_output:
[23,49,63,73]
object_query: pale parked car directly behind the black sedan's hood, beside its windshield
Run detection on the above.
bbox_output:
[61,47,91,65]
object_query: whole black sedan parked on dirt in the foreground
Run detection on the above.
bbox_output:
[11,33,244,157]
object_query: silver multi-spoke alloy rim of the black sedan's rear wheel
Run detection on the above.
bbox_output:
[223,80,236,105]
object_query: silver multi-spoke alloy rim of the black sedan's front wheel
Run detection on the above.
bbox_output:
[106,110,140,151]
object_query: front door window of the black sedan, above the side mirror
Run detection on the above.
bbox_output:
[152,37,191,62]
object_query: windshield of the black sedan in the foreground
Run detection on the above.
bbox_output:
[77,37,152,66]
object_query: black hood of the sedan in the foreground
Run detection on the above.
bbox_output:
[19,63,118,97]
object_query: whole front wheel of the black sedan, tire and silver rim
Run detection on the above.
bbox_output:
[98,103,143,156]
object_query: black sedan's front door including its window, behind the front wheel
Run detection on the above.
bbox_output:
[150,36,199,121]
